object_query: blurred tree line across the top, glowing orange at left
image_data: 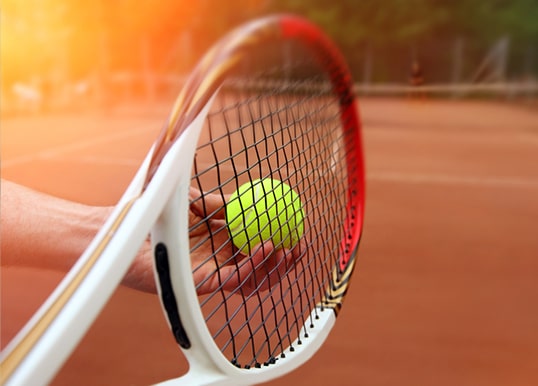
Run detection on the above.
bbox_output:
[0,0,538,98]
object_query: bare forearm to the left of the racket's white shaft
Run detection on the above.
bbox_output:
[0,180,106,271]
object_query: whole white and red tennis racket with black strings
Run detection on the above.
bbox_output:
[1,15,364,385]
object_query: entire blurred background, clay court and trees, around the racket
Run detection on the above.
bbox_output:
[0,0,538,386]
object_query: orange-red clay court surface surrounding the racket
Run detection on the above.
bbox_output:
[1,98,538,386]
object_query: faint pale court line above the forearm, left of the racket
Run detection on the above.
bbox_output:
[1,127,155,169]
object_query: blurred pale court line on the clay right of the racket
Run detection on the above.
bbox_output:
[366,172,538,189]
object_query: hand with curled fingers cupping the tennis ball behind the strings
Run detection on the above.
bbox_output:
[123,188,304,295]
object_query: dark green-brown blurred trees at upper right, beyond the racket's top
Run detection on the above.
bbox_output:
[271,0,538,82]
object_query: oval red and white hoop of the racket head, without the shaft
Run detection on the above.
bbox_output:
[152,15,364,385]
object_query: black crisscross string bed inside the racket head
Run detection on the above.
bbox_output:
[191,64,347,368]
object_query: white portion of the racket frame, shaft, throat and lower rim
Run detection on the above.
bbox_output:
[0,13,360,386]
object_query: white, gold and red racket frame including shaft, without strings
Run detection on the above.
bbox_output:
[0,15,364,385]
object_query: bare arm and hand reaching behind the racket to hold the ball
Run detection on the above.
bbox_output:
[0,180,300,294]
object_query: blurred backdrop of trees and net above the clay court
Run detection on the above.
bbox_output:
[1,0,538,112]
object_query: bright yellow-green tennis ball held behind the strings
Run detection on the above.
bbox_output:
[226,178,304,254]
